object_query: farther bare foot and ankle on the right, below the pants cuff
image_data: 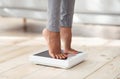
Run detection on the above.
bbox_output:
[60,27,78,54]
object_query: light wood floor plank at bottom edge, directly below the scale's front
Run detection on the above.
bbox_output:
[22,67,66,79]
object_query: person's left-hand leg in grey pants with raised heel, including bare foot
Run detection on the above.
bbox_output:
[43,0,67,59]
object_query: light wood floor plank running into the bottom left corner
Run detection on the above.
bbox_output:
[0,62,43,79]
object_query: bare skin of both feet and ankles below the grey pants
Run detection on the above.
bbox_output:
[43,27,77,59]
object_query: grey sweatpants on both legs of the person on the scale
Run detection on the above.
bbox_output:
[46,0,75,32]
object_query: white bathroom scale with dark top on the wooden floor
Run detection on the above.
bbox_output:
[29,50,86,69]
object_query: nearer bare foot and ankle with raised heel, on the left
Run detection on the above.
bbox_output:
[43,29,67,59]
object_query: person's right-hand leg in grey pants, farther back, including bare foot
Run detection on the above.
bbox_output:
[60,0,77,53]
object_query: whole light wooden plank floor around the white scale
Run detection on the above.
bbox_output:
[0,33,120,79]
